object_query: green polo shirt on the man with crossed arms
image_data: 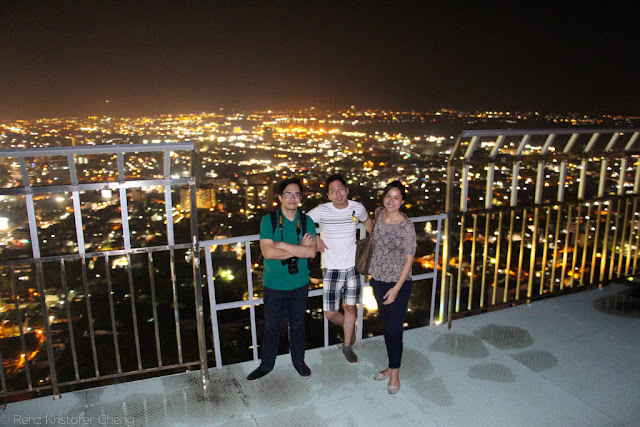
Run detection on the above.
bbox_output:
[260,211,316,291]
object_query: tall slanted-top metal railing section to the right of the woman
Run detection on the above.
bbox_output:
[441,129,640,320]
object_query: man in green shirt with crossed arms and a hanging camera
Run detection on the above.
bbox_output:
[247,178,316,381]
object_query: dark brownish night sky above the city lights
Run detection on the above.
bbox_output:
[0,0,640,120]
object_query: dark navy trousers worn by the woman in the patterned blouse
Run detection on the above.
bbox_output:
[370,279,411,369]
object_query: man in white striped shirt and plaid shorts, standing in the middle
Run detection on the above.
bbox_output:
[307,175,373,364]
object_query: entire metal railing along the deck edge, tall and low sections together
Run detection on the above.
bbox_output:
[6,129,640,398]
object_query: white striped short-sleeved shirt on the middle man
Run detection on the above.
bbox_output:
[307,200,369,270]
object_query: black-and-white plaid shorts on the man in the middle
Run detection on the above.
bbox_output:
[322,267,362,311]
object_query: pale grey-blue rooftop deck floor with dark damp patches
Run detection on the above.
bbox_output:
[0,284,640,426]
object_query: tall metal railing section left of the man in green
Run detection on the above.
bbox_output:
[0,143,206,402]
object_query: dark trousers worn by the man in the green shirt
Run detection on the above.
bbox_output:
[260,284,309,371]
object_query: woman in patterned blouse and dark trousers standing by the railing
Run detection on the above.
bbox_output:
[369,181,416,394]
